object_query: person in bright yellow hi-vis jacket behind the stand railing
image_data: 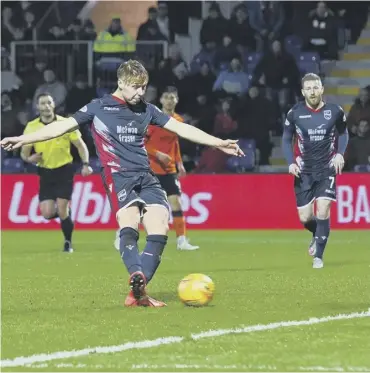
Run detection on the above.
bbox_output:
[94,17,136,55]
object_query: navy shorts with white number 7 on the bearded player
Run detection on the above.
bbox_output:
[294,174,337,208]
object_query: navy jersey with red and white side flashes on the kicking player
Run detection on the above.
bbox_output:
[73,94,170,171]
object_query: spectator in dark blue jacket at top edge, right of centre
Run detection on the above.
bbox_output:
[246,1,285,50]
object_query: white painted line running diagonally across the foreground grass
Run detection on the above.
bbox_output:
[0,308,370,368]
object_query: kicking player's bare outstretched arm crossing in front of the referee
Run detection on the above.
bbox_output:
[0,117,78,150]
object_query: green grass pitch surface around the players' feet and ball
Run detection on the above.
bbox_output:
[1,231,370,371]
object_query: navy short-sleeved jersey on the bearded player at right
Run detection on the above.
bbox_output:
[283,102,347,173]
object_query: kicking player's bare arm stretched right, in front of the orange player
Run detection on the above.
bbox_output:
[164,118,244,157]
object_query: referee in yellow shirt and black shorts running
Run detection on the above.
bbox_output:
[21,93,92,253]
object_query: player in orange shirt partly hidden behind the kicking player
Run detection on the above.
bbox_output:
[145,87,199,250]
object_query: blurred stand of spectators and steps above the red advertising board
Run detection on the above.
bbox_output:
[1,1,370,173]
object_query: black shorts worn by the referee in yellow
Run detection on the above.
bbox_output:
[38,163,75,202]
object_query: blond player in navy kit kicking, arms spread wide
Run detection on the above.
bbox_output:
[1,60,244,307]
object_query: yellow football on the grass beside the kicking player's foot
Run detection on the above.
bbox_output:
[177,273,215,307]
